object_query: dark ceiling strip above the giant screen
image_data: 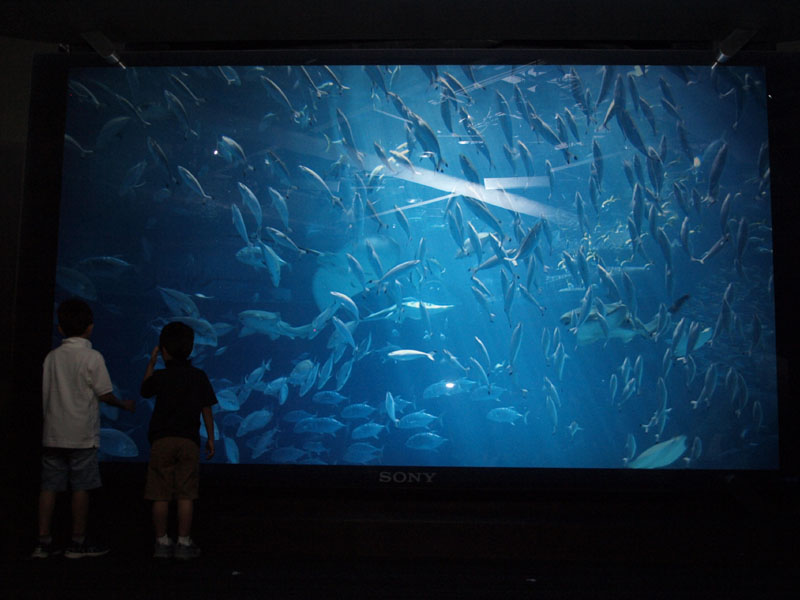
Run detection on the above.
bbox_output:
[0,0,800,51]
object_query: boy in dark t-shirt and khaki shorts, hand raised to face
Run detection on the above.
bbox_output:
[141,322,217,559]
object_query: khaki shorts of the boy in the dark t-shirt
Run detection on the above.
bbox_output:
[144,437,200,500]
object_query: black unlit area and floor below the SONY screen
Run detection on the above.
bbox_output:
[0,481,800,599]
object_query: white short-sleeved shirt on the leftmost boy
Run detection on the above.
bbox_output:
[42,337,113,448]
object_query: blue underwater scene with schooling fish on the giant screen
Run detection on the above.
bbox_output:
[54,64,779,469]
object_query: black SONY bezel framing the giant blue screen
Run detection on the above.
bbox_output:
[14,48,800,493]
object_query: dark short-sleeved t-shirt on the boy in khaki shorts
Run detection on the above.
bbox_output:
[140,360,217,446]
